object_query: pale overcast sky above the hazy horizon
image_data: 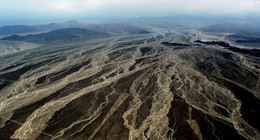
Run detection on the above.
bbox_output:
[0,0,260,19]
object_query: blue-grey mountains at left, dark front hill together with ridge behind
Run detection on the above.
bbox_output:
[0,21,150,43]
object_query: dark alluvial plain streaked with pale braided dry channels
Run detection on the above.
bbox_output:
[0,31,260,140]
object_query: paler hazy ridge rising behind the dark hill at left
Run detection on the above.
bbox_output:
[0,20,149,36]
